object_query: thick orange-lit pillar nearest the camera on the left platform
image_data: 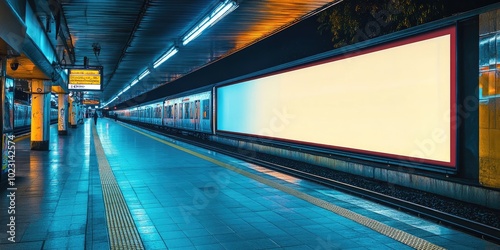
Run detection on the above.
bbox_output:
[31,79,51,150]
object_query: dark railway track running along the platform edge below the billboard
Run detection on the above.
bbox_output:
[128,124,500,244]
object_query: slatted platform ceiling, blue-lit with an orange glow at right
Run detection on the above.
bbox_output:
[61,0,332,105]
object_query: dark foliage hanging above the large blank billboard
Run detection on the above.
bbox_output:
[318,0,450,48]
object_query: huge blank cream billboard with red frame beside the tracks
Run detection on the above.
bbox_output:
[217,27,456,168]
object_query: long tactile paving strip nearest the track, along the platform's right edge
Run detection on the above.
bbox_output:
[120,123,445,249]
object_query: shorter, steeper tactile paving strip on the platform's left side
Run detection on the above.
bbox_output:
[92,126,144,249]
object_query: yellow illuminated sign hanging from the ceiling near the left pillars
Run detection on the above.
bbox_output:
[68,69,102,90]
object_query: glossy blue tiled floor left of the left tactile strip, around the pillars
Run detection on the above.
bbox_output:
[0,120,109,249]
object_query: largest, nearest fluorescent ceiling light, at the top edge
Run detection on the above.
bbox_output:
[182,0,238,46]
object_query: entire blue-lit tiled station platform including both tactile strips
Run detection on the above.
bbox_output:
[0,119,500,249]
